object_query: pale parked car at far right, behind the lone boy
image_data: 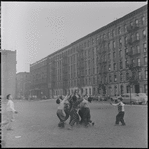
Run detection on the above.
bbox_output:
[118,93,144,104]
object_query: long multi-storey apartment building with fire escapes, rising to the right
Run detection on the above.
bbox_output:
[30,5,148,98]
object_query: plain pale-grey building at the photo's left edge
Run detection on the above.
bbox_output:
[1,50,17,98]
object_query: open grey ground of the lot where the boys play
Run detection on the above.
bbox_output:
[2,100,148,148]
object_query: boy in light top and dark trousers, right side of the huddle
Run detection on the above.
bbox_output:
[78,95,94,127]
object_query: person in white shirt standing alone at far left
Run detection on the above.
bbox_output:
[6,94,18,130]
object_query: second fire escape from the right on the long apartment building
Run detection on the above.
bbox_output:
[98,39,108,95]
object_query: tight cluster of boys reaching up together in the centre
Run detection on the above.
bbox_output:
[56,91,94,130]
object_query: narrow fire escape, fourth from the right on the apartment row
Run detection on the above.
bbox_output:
[62,55,68,94]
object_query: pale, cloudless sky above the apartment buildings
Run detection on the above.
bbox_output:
[1,2,147,73]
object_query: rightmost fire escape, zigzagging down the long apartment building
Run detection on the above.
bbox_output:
[126,25,142,92]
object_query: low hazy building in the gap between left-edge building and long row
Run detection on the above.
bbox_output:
[16,72,30,99]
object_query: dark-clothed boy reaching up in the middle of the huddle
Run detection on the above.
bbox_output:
[68,93,83,130]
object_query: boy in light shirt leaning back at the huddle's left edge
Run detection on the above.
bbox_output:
[56,95,69,128]
